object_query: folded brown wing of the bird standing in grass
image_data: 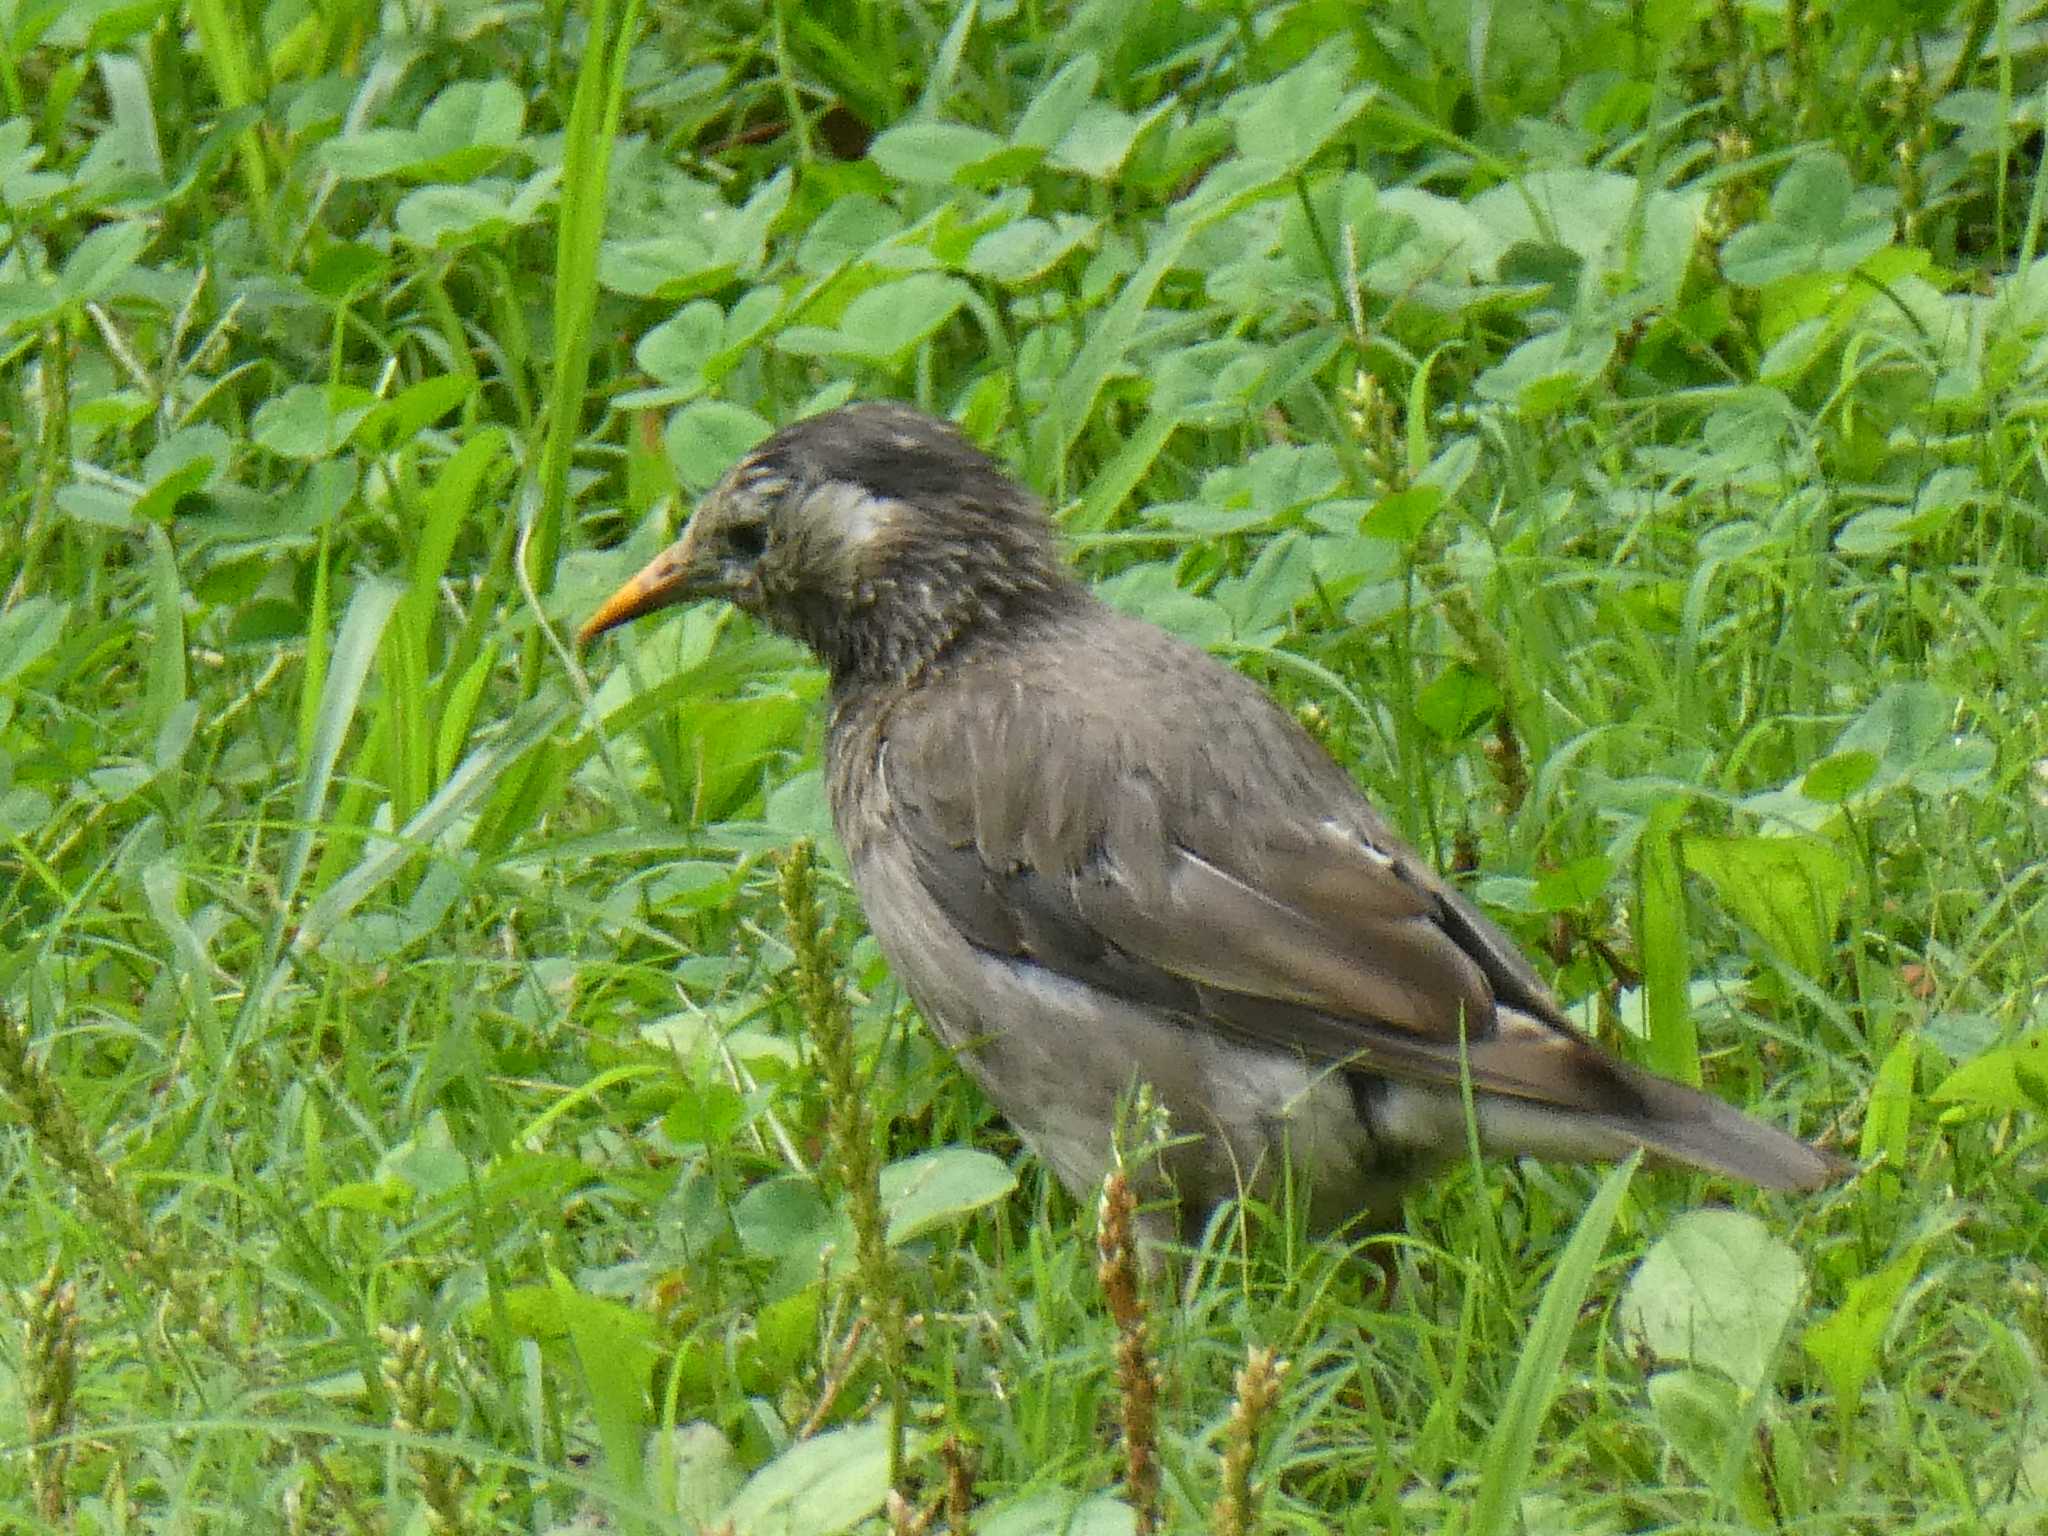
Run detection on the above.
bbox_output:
[883,657,1640,1114]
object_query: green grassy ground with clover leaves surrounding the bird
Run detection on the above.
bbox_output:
[0,0,2048,1536]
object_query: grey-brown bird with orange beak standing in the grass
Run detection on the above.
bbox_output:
[582,401,1847,1235]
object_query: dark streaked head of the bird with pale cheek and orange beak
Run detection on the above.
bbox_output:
[582,403,1077,678]
